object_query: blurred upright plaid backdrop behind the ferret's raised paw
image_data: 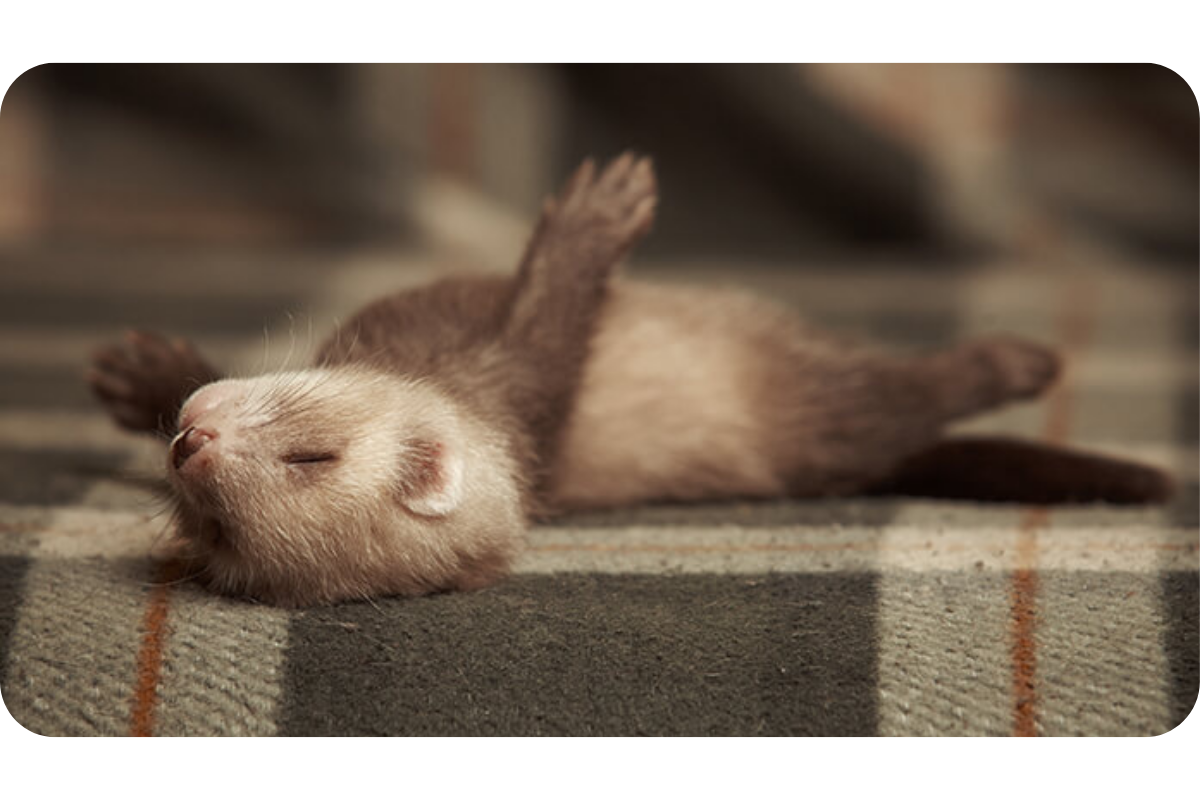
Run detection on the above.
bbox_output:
[0,62,1200,265]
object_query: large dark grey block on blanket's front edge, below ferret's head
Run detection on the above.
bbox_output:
[280,573,877,736]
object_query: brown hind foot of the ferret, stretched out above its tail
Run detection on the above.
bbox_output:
[923,336,1061,421]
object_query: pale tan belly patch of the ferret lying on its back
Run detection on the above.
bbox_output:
[550,283,788,510]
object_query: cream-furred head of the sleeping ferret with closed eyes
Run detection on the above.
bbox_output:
[167,367,524,606]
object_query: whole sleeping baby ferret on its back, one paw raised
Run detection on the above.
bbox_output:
[88,154,1171,607]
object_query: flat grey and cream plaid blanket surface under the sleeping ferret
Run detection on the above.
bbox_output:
[0,249,1200,736]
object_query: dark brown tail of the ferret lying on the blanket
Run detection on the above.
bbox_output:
[871,437,1175,505]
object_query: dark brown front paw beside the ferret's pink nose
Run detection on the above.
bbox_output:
[85,331,221,435]
